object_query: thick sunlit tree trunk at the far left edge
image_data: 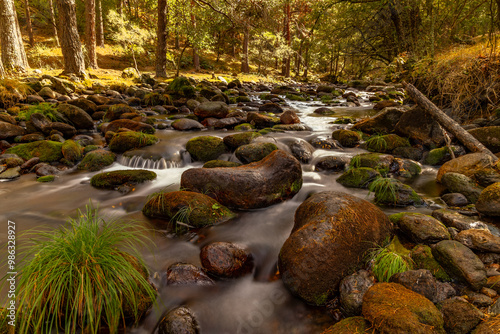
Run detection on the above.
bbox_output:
[0,0,29,72]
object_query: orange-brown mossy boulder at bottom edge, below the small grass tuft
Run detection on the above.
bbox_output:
[363,283,446,334]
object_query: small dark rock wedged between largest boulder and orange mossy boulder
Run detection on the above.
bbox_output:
[339,270,375,316]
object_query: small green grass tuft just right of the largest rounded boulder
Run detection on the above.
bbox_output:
[370,237,413,282]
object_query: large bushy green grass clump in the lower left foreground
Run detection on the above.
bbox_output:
[11,206,155,334]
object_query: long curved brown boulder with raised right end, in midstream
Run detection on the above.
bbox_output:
[181,150,302,210]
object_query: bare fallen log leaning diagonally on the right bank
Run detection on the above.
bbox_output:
[403,81,498,161]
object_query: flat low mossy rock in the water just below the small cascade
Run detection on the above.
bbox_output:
[90,169,156,189]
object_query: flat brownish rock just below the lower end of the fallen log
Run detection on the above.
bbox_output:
[436,153,494,182]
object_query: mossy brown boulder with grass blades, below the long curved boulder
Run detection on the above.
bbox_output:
[142,191,235,228]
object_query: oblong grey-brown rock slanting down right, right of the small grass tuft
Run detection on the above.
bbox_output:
[432,240,486,291]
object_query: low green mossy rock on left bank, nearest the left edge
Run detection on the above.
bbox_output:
[6,140,63,162]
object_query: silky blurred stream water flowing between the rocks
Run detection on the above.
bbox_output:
[0,90,446,334]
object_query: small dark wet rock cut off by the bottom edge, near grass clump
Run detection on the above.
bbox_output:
[158,306,200,334]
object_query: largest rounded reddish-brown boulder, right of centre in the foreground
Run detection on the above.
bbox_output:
[278,191,391,305]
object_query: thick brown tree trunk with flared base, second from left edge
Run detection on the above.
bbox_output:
[57,0,87,77]
